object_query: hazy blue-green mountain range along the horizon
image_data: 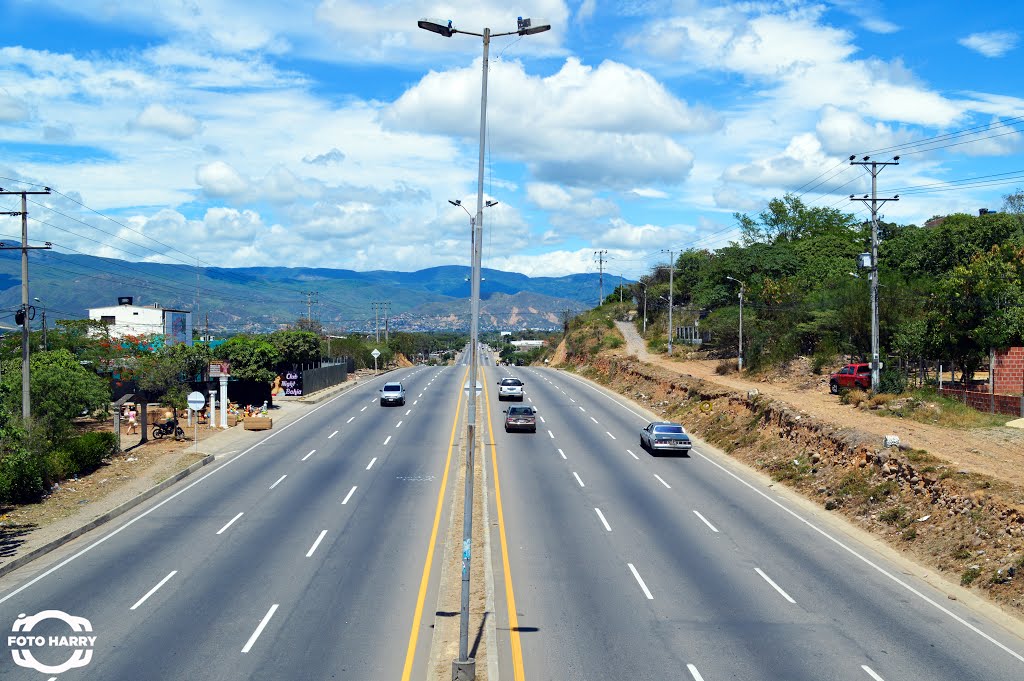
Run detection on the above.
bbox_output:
[0,251,616,333]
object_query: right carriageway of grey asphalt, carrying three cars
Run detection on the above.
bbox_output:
[487,368,1024,681]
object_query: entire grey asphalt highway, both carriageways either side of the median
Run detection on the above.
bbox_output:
[0,353,1024,681]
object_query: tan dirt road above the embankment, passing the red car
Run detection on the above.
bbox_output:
[615,322,1024,485]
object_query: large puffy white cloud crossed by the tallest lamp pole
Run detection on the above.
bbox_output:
[383,58,719,188]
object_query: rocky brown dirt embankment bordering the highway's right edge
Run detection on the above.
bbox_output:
[575,354,1024,618]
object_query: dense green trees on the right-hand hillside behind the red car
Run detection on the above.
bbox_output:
[614,189,1024,385]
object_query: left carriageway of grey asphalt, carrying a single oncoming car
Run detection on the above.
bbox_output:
[0,368,464,679]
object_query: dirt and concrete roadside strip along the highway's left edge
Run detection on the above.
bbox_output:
[0,377,362,576]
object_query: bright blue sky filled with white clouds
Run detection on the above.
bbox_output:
[0,0,1024,276]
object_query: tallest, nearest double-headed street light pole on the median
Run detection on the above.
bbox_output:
[414,16,551,681]
